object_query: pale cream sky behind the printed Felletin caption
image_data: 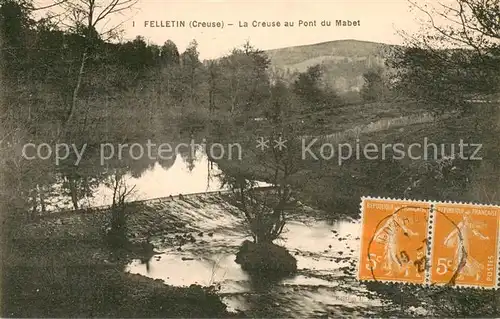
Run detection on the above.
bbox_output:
[37,0,428,59]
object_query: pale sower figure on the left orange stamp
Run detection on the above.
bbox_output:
[374,214,418,276]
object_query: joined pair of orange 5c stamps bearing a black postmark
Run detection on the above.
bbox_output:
[358,197,500,289]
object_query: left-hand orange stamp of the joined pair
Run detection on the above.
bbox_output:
[358,198,431,284]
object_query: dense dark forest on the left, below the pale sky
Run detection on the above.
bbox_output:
[0,0,350,148]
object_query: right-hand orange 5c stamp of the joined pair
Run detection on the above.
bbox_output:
[430,203,500,288]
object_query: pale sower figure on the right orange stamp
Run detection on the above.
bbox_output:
[444,212,489,280]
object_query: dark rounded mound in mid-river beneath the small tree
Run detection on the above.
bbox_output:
[236,240,297,275]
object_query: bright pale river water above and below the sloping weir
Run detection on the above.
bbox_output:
[115,152,404,318]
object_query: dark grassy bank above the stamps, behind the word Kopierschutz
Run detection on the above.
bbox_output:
[216,102,498,218]
